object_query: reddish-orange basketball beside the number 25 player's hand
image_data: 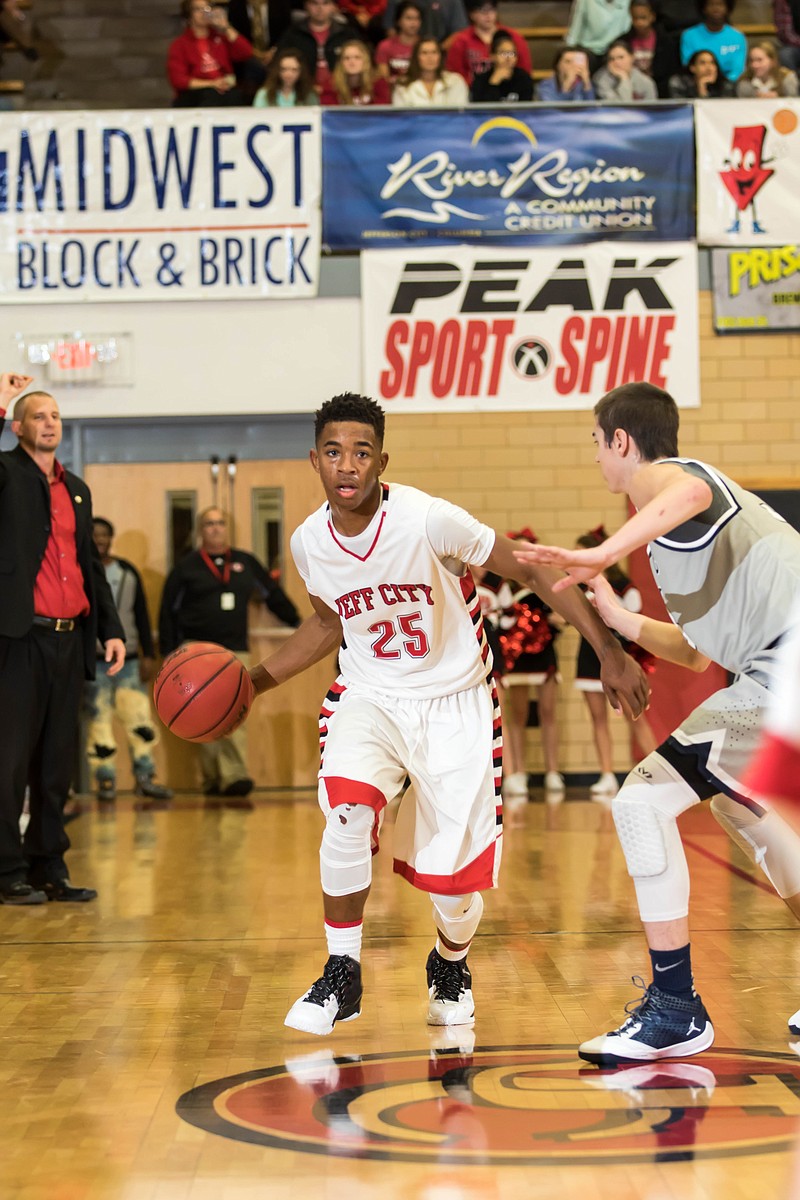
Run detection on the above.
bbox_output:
[154,642,254,742]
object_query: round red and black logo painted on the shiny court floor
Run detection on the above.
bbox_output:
[178,1031,800,1165]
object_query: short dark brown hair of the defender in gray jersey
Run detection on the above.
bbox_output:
[595,383,679,462]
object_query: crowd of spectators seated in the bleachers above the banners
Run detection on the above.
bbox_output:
[167,0,800,108]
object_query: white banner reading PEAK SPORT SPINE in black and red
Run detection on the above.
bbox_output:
[361,242,700,413]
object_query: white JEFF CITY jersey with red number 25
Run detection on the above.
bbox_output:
[291,484,494,700]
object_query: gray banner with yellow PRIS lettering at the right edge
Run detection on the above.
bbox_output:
[711,245,800,334]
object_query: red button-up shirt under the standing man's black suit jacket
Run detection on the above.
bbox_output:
[34,462,89,617]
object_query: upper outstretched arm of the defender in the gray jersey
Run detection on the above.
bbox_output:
[515,463,712,592]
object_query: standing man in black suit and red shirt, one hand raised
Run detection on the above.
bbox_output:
[0,374,125,905]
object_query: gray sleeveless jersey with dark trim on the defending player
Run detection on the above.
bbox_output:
[648,458,800,688]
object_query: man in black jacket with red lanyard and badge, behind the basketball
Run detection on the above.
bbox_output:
[158,508,300,796]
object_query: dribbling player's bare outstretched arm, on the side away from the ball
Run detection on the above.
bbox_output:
[483,534,650,716]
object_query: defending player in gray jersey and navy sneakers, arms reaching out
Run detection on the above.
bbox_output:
[517,383,800,1066]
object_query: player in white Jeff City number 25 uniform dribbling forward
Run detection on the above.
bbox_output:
[251,392,646,1034]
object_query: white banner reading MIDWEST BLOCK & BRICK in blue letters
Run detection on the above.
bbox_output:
[0,108,320,304]
